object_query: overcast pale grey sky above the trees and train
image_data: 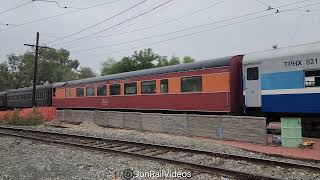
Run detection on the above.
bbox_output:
[0,0,320,72]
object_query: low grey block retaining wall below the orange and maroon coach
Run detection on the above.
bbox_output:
[57,110,267,144]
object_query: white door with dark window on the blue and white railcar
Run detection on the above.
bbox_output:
[245,64,261,107]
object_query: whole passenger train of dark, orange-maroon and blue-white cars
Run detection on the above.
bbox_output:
[0,42,320,135]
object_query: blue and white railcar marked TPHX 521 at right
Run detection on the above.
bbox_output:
[243,43,320,114]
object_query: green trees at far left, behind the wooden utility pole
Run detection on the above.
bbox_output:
[0,49,95,89]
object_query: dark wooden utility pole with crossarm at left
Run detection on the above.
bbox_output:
[24,32,48,107]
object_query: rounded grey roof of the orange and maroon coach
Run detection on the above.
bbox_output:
[67,57,231,85]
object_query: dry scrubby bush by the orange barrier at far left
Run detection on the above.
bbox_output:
[2,108,45,126]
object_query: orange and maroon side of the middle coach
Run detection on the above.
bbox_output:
[53,67,235,113]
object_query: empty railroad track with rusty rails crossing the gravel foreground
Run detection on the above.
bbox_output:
[0,127,320,179]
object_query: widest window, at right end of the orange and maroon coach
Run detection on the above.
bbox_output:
[181,76,202,92]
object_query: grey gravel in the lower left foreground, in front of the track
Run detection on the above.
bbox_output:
[0,136,221,180]
